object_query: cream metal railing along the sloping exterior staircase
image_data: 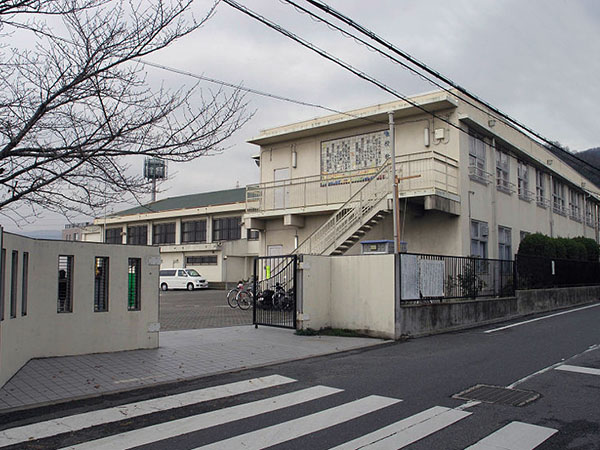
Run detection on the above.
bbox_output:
[292,160,392,255]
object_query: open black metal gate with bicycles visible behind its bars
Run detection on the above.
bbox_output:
[252,255,298,329]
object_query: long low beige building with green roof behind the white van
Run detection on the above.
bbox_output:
[83,188,259,285]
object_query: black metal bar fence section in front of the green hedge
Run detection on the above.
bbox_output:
[516,255,600,289]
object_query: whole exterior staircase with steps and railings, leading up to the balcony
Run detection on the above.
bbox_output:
[293,160,392,255]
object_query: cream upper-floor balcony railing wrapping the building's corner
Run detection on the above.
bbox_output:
[246,151,458,213]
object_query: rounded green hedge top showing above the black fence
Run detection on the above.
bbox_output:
[517,233,600,261]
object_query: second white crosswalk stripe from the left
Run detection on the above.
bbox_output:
[62,386,342,450]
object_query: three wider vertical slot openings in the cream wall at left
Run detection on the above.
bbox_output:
[56,255,142,313]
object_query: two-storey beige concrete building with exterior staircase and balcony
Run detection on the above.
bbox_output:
[244,91,600,259]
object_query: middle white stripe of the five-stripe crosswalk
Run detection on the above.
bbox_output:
[195,395,401,450]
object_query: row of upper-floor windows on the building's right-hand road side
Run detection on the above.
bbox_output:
[469,132,594,226]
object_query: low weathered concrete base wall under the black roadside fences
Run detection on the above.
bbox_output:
[398,286,600,337]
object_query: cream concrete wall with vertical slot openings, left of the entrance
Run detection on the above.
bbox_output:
[0,233,160,386]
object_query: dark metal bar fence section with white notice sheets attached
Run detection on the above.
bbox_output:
[400,253,516,301]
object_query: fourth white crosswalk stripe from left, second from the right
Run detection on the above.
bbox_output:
[331,406,472,450]
